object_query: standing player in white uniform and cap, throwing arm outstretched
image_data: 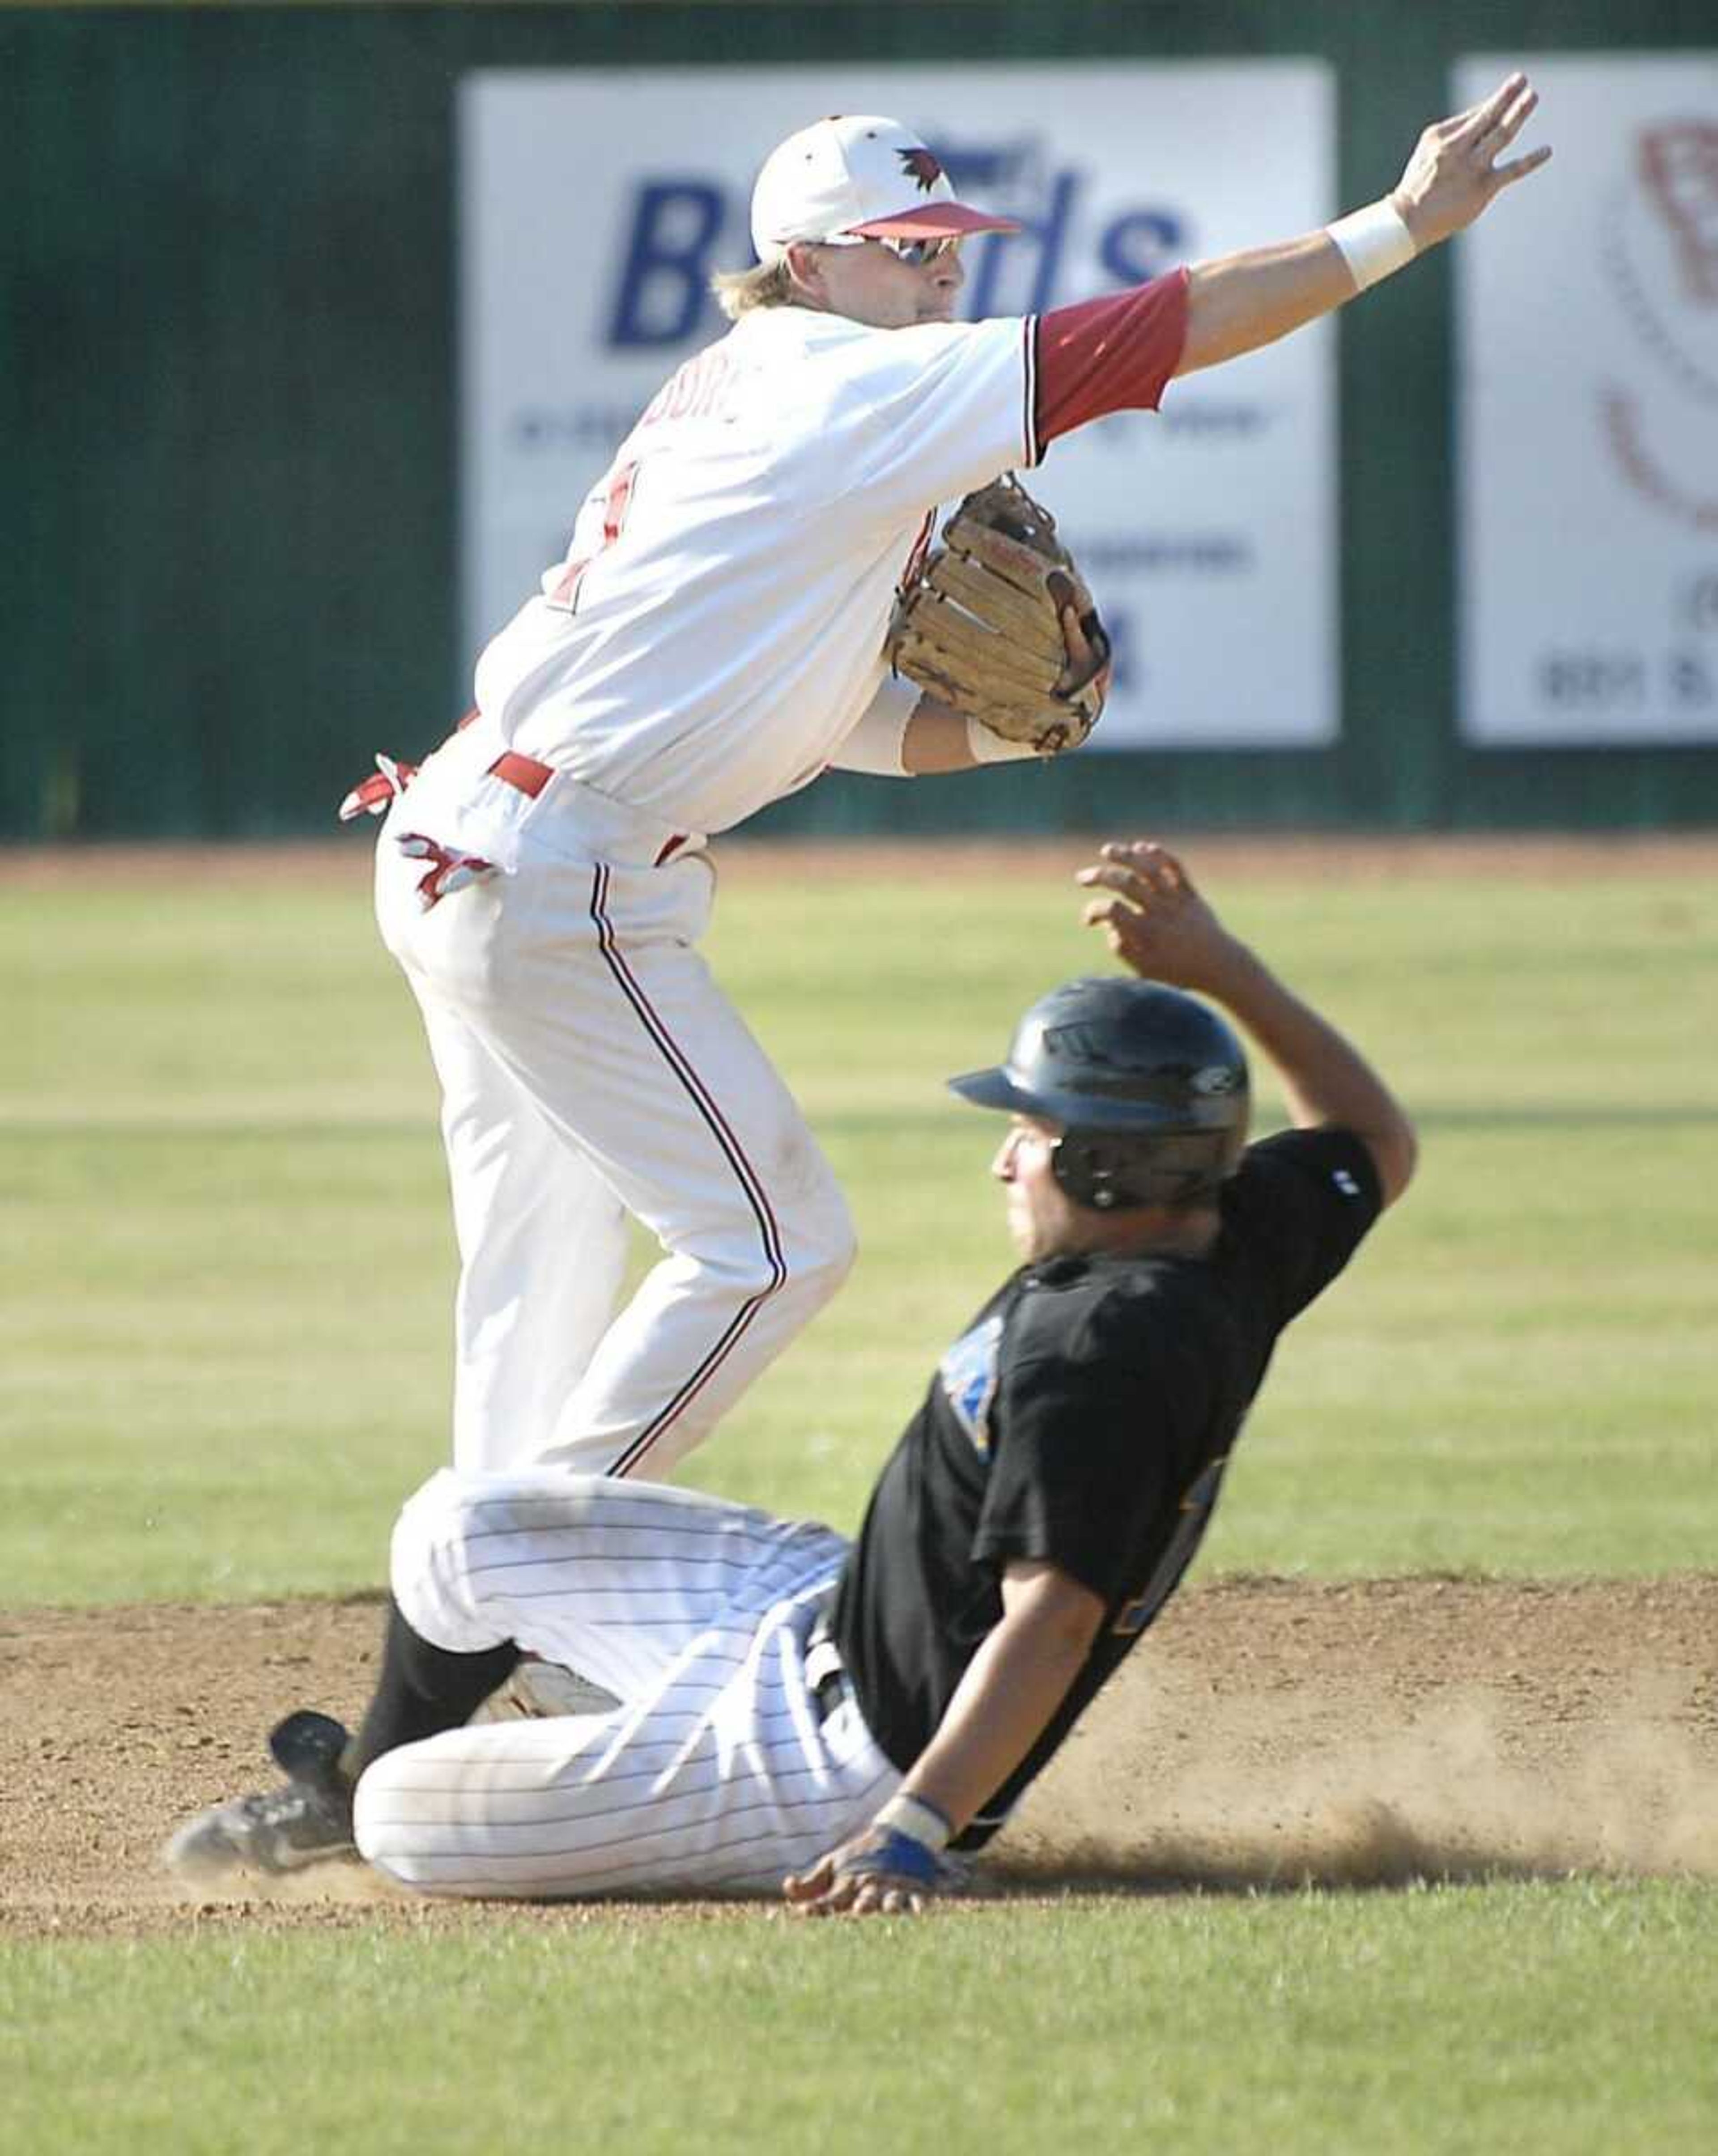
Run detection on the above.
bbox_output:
[358,93,1548,1492]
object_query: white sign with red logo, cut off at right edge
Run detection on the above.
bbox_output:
[1455,52,1718,746]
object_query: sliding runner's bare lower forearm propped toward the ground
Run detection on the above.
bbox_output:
[903,1598,1095,1833]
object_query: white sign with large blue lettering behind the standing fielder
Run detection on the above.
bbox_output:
[459,60,1339,748]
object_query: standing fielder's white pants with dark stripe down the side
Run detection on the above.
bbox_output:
[377,726,854,1477]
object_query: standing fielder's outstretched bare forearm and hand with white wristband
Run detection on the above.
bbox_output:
[1175,73,1550,375]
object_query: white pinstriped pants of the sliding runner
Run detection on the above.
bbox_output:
[356,1468,901,1899]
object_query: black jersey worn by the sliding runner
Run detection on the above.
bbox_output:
[830,1130,1380,1848]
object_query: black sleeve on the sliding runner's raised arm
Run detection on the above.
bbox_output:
[1222,1125,1384,1330]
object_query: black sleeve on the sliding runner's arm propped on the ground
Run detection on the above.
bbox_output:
[972,1296,1218,1602]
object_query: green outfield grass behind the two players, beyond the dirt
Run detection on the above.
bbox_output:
[0,840,1718,1604]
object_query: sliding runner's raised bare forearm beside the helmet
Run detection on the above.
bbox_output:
[1203,938,1416,1205]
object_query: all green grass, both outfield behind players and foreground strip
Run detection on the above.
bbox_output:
[0,847,1718,2156]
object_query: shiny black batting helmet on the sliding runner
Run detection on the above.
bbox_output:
[948,975,1250,1212]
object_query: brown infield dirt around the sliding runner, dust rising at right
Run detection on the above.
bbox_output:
[0,1576,1718,1936]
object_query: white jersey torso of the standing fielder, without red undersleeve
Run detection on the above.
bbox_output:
[465,308,1037,832]
